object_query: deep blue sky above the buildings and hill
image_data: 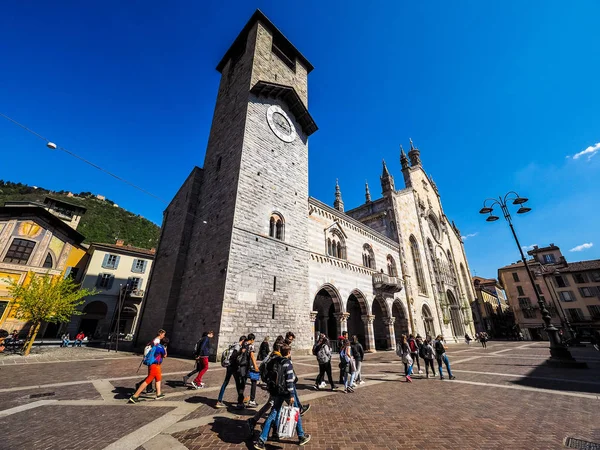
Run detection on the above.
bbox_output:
[0,0,600,277]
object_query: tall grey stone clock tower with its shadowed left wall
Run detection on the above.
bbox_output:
[142,10,317,354]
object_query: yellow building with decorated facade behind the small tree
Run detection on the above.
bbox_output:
[0,197,86,337]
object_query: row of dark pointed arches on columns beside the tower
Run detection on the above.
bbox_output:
[311,285,414,351]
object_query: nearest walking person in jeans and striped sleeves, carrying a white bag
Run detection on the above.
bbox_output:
[254,344,311,450]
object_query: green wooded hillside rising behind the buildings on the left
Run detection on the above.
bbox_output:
[0,180,160,249]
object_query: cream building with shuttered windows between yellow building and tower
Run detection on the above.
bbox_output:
[61,240,155,339]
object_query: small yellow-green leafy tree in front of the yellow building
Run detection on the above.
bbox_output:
[8,272,96,356]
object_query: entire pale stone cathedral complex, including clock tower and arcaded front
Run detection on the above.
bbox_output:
[137,11,473,354]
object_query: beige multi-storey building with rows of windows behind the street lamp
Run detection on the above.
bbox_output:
[498,244,600,339]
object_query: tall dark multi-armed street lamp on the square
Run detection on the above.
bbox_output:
[479,191,587,367]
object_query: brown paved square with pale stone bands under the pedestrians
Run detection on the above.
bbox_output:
[0,341,600,450]
